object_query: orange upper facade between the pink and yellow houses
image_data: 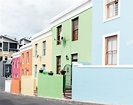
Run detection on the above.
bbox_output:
[20,49,32,76]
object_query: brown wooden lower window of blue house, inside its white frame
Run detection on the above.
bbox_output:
[105,35,117,65]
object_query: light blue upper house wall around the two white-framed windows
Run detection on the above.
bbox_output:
[92,0,133,65]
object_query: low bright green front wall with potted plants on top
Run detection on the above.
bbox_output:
[38,73,63,98]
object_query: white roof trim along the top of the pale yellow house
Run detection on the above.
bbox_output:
[31,27,52,42]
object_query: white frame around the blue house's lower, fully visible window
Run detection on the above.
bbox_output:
[102,32,120,66]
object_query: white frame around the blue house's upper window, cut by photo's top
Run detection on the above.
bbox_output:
[103,0,121,22]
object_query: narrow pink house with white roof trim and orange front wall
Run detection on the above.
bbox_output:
[11,52,21,94]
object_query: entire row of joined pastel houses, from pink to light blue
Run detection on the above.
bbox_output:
[8,0,133,105]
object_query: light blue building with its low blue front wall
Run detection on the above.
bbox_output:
[72,0,133,105]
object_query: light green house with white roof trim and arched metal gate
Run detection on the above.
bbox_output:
[51,0,92,99]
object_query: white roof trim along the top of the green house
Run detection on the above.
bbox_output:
[50,0,92,27]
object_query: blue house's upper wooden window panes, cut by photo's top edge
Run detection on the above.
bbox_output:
[105,0,119,19]
